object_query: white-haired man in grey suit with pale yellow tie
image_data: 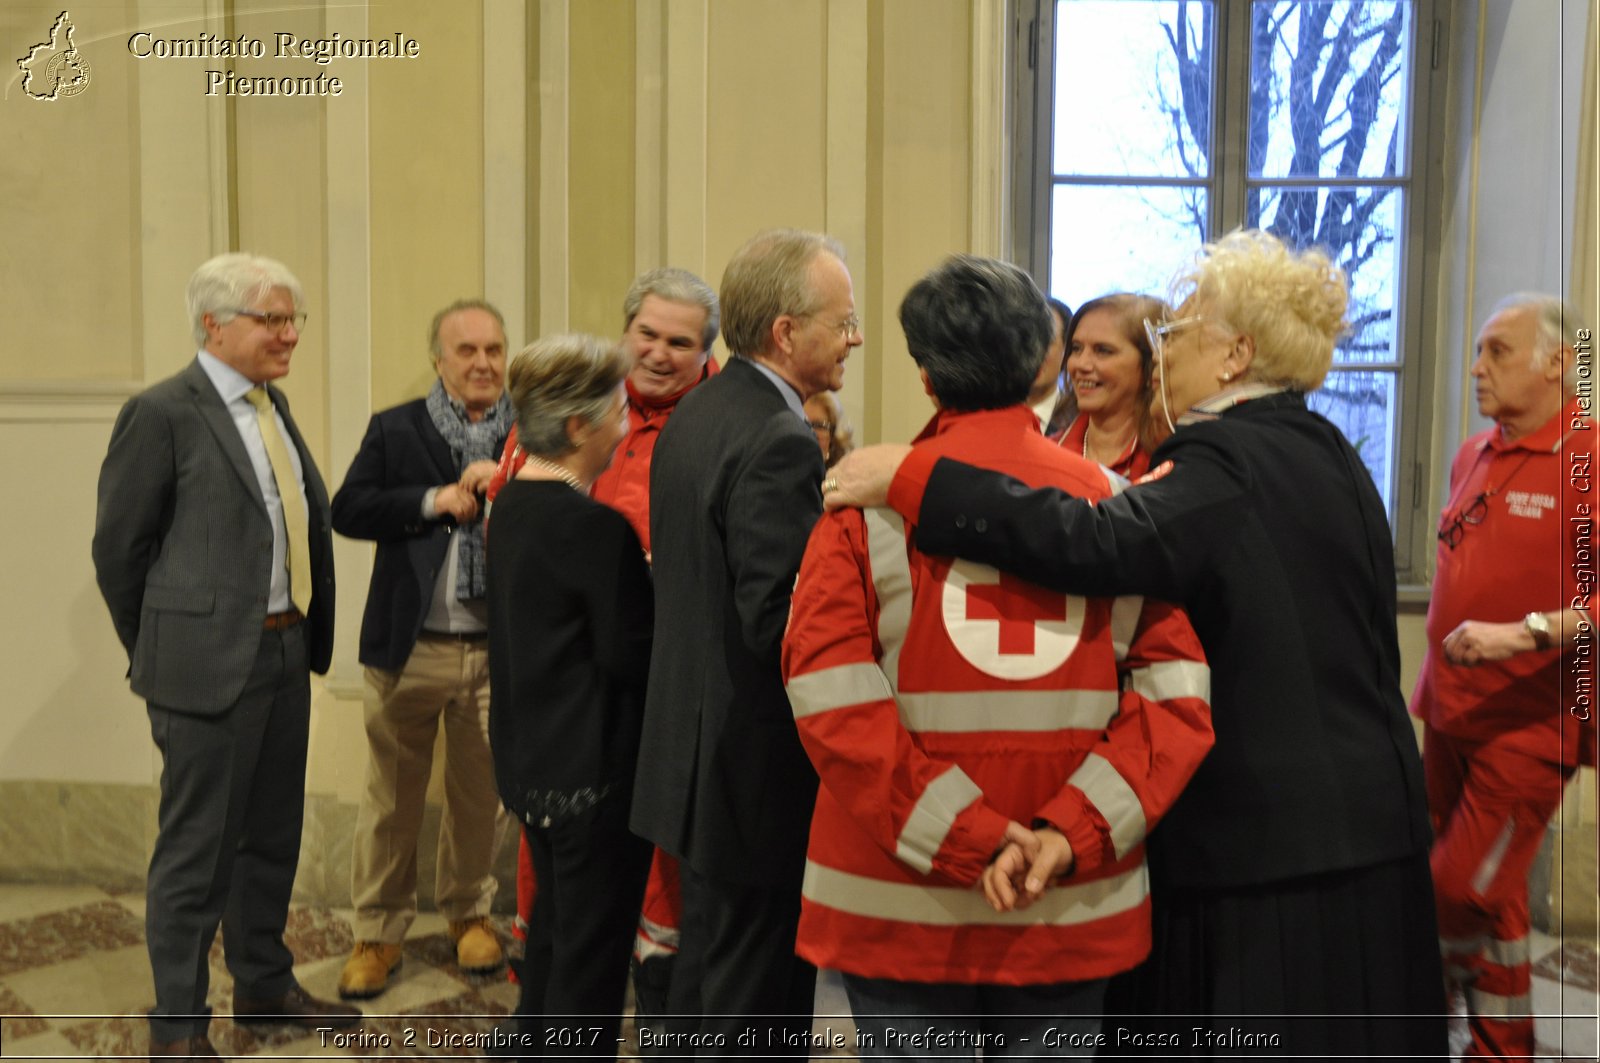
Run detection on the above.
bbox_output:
[94,253,360,1058]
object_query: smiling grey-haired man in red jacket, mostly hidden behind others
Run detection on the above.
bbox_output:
[488,266,722,1021]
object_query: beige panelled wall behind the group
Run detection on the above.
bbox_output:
[0,0,1594,882]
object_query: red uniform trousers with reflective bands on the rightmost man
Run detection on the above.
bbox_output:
[1422,727,1573,1058]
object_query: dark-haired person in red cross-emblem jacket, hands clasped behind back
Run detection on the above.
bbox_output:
[784,256,1211,1058]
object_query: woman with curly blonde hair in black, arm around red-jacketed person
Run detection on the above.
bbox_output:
[826,232,1445,1058]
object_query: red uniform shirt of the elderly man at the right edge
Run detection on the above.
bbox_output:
[1411,399,1600,765]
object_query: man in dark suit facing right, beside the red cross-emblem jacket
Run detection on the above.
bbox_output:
[632,229,861,1057]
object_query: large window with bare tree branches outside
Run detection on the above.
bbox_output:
[1016,0,1442,580]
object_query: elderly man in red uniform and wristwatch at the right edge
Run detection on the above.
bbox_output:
[1411,295,1597,1057]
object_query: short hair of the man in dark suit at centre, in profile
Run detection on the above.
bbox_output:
[722,229,845,357]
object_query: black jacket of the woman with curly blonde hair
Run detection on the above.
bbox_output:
[896,392,1430,889]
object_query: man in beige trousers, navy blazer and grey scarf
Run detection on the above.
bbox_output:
[333,299,515,997]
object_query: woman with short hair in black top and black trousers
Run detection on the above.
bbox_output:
[488,336,654,1057]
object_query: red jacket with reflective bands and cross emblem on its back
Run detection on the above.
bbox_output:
[784,407,1211,985]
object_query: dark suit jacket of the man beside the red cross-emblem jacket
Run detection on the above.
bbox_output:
[632,359,822,887]
